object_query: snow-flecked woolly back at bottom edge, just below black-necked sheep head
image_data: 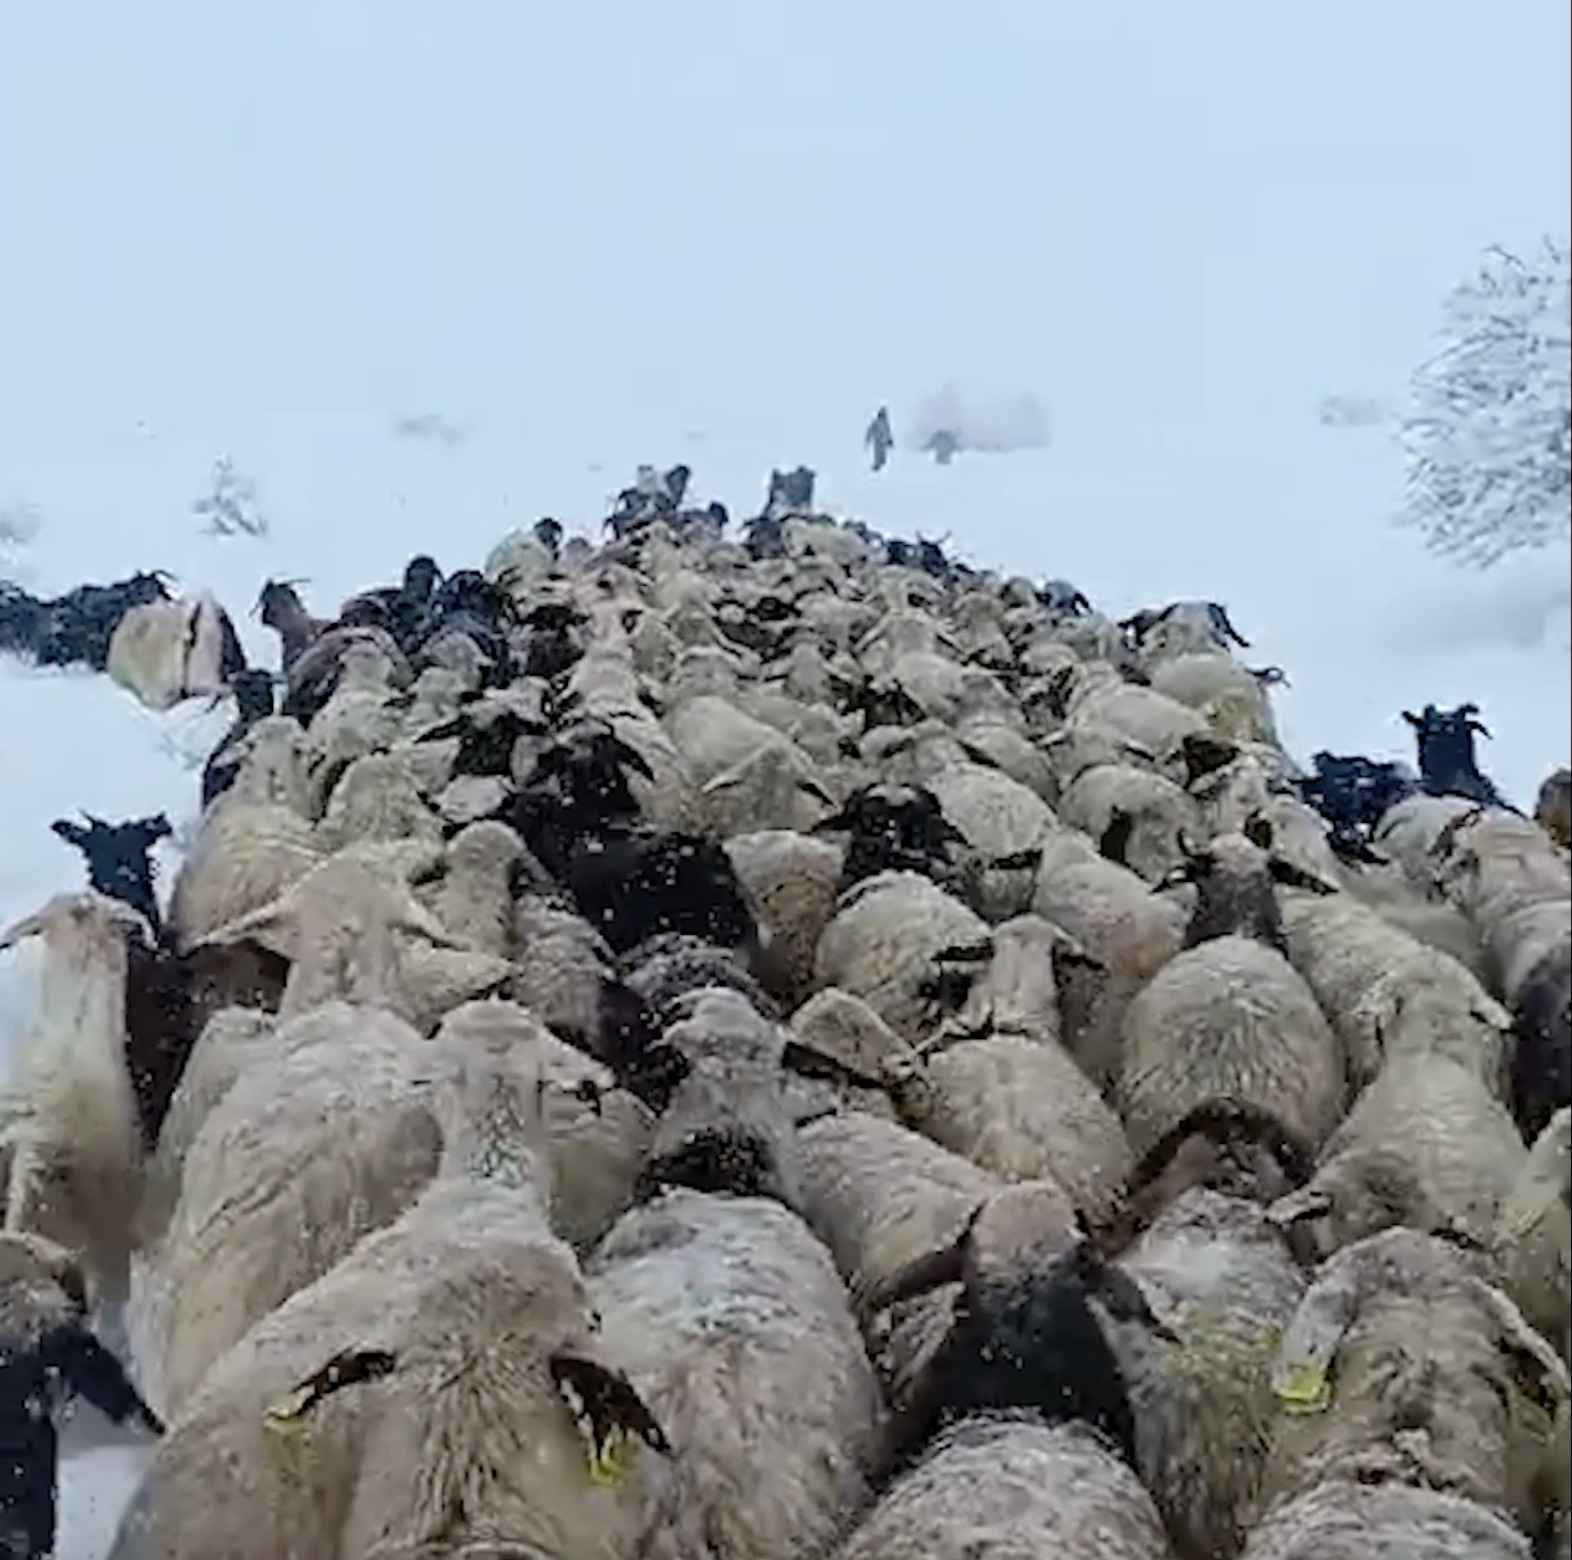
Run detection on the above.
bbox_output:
[835,1414,1173,1560]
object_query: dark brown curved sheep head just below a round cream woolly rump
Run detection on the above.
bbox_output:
[1121,1098,1316,1244]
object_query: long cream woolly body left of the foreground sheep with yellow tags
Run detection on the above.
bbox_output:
[138,1003,442,1411]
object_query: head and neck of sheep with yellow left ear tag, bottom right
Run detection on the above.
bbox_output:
[1262,1228,1569,1532]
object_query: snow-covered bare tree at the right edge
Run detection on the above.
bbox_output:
[1399,237,1572,568]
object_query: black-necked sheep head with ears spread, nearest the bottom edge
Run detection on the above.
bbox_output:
[877,1203,1174,1467]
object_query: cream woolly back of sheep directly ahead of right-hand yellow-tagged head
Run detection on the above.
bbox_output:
[1273,1054,1526,1255]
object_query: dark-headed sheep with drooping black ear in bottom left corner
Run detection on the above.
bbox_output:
[0,1233,163,1560]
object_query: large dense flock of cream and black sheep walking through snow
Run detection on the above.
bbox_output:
[0,465,1572,1560]
